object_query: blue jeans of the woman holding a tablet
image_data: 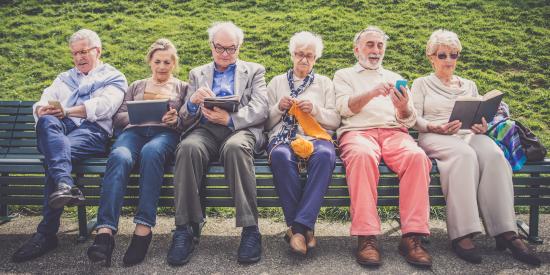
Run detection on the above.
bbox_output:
[97,126,180,232]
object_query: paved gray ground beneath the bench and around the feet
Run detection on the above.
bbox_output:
[0,215,550,274]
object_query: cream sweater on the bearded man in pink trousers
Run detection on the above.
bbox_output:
[334,63,416,138]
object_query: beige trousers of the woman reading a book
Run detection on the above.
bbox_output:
[418,133,516,240]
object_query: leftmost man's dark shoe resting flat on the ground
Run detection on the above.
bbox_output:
[11,232,57,263]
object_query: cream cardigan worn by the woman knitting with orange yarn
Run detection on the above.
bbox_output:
[265,73,340,141]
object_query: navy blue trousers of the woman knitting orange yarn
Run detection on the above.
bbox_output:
[268,140,336,229]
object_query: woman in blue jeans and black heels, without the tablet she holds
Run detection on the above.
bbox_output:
[88,39,188,266]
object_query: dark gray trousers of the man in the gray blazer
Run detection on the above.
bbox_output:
[174,123,258,230]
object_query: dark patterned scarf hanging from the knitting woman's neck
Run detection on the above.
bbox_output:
[273,69,315,148]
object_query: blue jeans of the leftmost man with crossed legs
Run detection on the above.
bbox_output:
[36,115,109,235]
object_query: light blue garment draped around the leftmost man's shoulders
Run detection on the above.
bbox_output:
[59,64,128,107]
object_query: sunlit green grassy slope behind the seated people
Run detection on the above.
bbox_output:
[0,0,550,147]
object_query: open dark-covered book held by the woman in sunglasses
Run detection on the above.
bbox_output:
[449,90,504,129]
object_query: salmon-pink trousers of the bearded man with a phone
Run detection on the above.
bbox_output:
[340,128,432,235]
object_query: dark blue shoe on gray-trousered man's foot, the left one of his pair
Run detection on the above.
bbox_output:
[166,226,195,265]
